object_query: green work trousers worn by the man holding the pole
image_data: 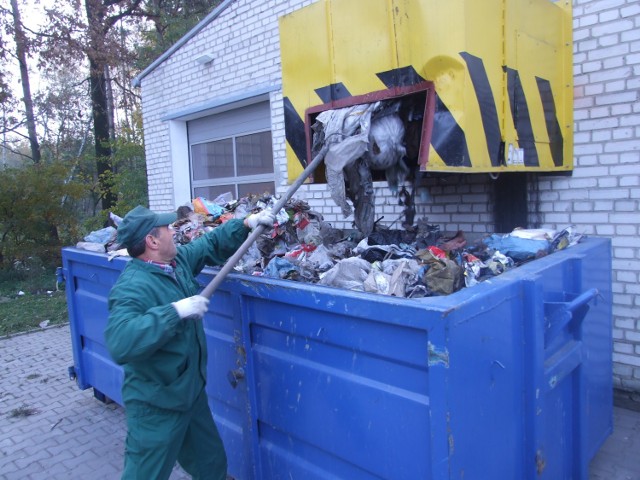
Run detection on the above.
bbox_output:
[122,391,227,480]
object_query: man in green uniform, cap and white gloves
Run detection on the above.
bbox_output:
[105,206,274,480]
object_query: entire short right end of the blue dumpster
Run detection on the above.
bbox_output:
[440,240,612,480]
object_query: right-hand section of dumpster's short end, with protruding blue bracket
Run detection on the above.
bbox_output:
[531,244,613,479]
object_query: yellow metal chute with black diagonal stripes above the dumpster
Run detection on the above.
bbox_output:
[280,0,573,179]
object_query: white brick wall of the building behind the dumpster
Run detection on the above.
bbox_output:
[142,0,640,392]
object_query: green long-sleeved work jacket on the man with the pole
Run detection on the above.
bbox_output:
[104,219,249,411]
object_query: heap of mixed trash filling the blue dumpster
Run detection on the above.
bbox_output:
[76,194,581,298]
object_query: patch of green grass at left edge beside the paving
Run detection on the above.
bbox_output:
[0,268,69,336]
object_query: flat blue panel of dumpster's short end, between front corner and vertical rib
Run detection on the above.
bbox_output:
[443,282,525,479]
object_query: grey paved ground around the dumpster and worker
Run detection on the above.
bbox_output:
[0,326,640,480]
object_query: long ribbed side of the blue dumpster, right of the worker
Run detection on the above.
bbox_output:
[200,275,447,479]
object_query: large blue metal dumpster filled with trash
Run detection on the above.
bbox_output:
[63,238,613,480]
